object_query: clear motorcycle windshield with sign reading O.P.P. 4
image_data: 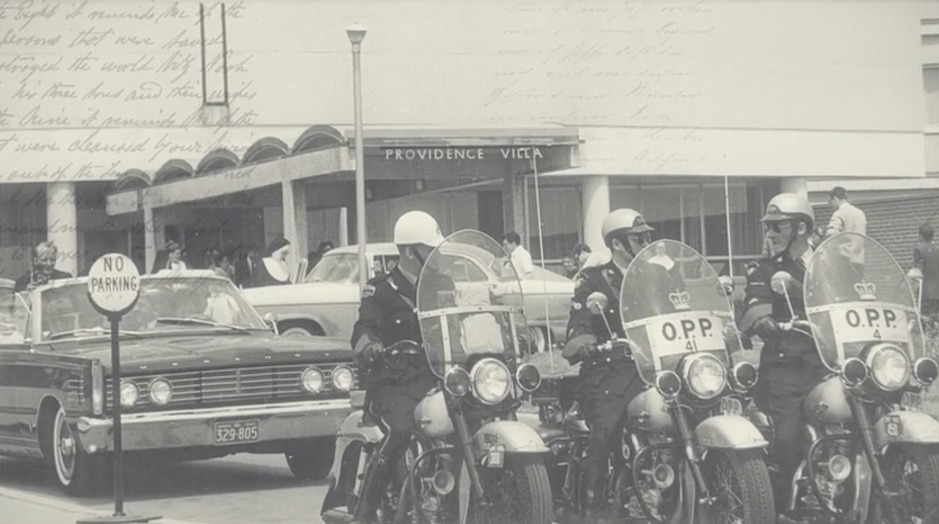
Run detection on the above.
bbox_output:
[803,232,925,371]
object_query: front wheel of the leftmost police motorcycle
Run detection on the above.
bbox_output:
[469,455,552,524]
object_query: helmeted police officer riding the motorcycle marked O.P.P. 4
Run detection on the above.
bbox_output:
[740,193,825,522]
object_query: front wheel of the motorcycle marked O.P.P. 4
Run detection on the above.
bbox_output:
[868,446,939,524]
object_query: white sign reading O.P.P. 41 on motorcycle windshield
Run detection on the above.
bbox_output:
[646,311,724,357]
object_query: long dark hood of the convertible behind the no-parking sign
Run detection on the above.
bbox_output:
[54,332,352,374]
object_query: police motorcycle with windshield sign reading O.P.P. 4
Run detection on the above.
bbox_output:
[772,232,939,524]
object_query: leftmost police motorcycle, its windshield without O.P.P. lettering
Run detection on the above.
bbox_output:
[322,230,551,524]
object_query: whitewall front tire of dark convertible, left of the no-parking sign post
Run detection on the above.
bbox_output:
[46,406,111,497]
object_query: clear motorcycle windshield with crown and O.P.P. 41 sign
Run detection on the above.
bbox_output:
[620,240,740,384]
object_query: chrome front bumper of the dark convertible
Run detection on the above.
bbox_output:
[75,399,352,453]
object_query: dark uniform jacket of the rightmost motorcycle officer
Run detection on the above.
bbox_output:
[740,255,818,366]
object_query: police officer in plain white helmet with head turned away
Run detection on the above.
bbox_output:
[352,211,452,522]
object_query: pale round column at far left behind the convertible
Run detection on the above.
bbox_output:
[46,182,78,276]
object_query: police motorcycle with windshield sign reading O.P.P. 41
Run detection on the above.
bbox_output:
[620,240,776,523]
